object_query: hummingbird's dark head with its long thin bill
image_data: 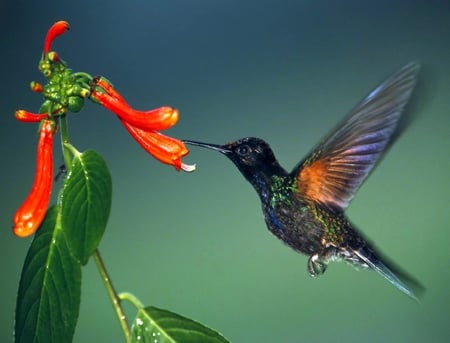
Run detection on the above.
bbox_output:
[184,137,284,183]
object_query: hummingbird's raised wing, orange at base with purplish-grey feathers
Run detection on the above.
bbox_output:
[292,63,419,209]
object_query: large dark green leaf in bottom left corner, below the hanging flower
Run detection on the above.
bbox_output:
[14,206,81,343]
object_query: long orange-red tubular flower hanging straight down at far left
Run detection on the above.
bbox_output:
[13,119,56,237]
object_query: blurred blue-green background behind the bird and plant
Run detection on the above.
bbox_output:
[0,0,450,342]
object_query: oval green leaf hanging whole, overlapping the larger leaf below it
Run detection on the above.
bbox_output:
[60,150,112,265]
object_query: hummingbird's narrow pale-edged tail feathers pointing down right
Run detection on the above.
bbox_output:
[354,249,425,302]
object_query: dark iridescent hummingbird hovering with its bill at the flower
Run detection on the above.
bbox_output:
[184,63,421,301]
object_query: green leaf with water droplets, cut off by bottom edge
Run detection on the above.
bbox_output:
[131,306,228,343]
